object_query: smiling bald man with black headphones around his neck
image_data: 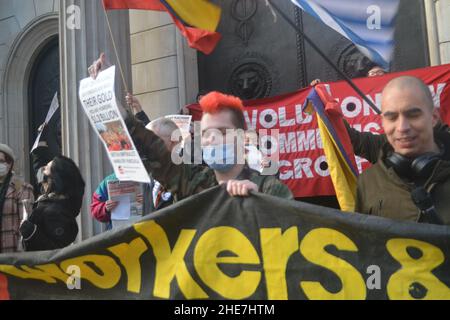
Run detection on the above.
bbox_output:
[355,76,450,225]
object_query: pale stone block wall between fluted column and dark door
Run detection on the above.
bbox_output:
[130,10,198,119]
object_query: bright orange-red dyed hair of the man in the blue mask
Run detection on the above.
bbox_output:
[199,91,247,130]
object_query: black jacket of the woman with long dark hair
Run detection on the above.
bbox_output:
[20,194,80,251]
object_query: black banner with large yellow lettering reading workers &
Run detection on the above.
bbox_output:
[0,187,450,299]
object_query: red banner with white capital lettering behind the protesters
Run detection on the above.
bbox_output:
[188,64,450,197]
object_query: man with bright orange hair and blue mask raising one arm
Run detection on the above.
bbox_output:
[125,92,293,201]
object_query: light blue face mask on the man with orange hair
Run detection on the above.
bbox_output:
[202,144,236,172]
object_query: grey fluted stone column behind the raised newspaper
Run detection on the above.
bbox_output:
[60,0,132,240]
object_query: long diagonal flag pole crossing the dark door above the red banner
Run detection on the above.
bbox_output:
[267,0,381,114]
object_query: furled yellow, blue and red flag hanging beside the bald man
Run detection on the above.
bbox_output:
[305,85,358,212]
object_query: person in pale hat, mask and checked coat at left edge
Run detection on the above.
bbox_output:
[0,144,34,253]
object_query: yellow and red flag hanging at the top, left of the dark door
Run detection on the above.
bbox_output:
[103,0,222,54]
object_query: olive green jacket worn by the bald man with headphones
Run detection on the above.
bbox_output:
[355,130,450,225]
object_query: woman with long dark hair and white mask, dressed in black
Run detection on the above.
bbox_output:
[20,142,85,251]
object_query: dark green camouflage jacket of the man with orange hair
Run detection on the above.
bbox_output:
[126,117,293,201]
